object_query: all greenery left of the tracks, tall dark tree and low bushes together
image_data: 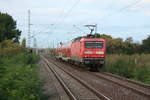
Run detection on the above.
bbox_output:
[0,13,46,100]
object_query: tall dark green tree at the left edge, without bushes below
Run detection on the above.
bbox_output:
[0,12,21,42]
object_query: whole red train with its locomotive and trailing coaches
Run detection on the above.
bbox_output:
[56,35,106,71]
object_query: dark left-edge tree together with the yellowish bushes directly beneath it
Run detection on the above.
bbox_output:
[0,12,25,59]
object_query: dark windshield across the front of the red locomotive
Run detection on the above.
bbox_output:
[84,41,103,48]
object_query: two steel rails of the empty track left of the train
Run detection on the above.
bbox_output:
[42,56,110,100]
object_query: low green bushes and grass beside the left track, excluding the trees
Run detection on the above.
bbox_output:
[0,52,46,100]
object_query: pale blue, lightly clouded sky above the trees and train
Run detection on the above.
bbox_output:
[0,0,150,47]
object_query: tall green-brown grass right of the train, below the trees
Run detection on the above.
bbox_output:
[105,54,150,85]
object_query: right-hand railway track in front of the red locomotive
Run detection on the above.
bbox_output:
[92,73,150,98]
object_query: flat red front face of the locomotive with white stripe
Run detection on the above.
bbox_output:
[81,38,106,66]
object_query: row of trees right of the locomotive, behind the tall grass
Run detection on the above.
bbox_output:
[94,34,150,55]
